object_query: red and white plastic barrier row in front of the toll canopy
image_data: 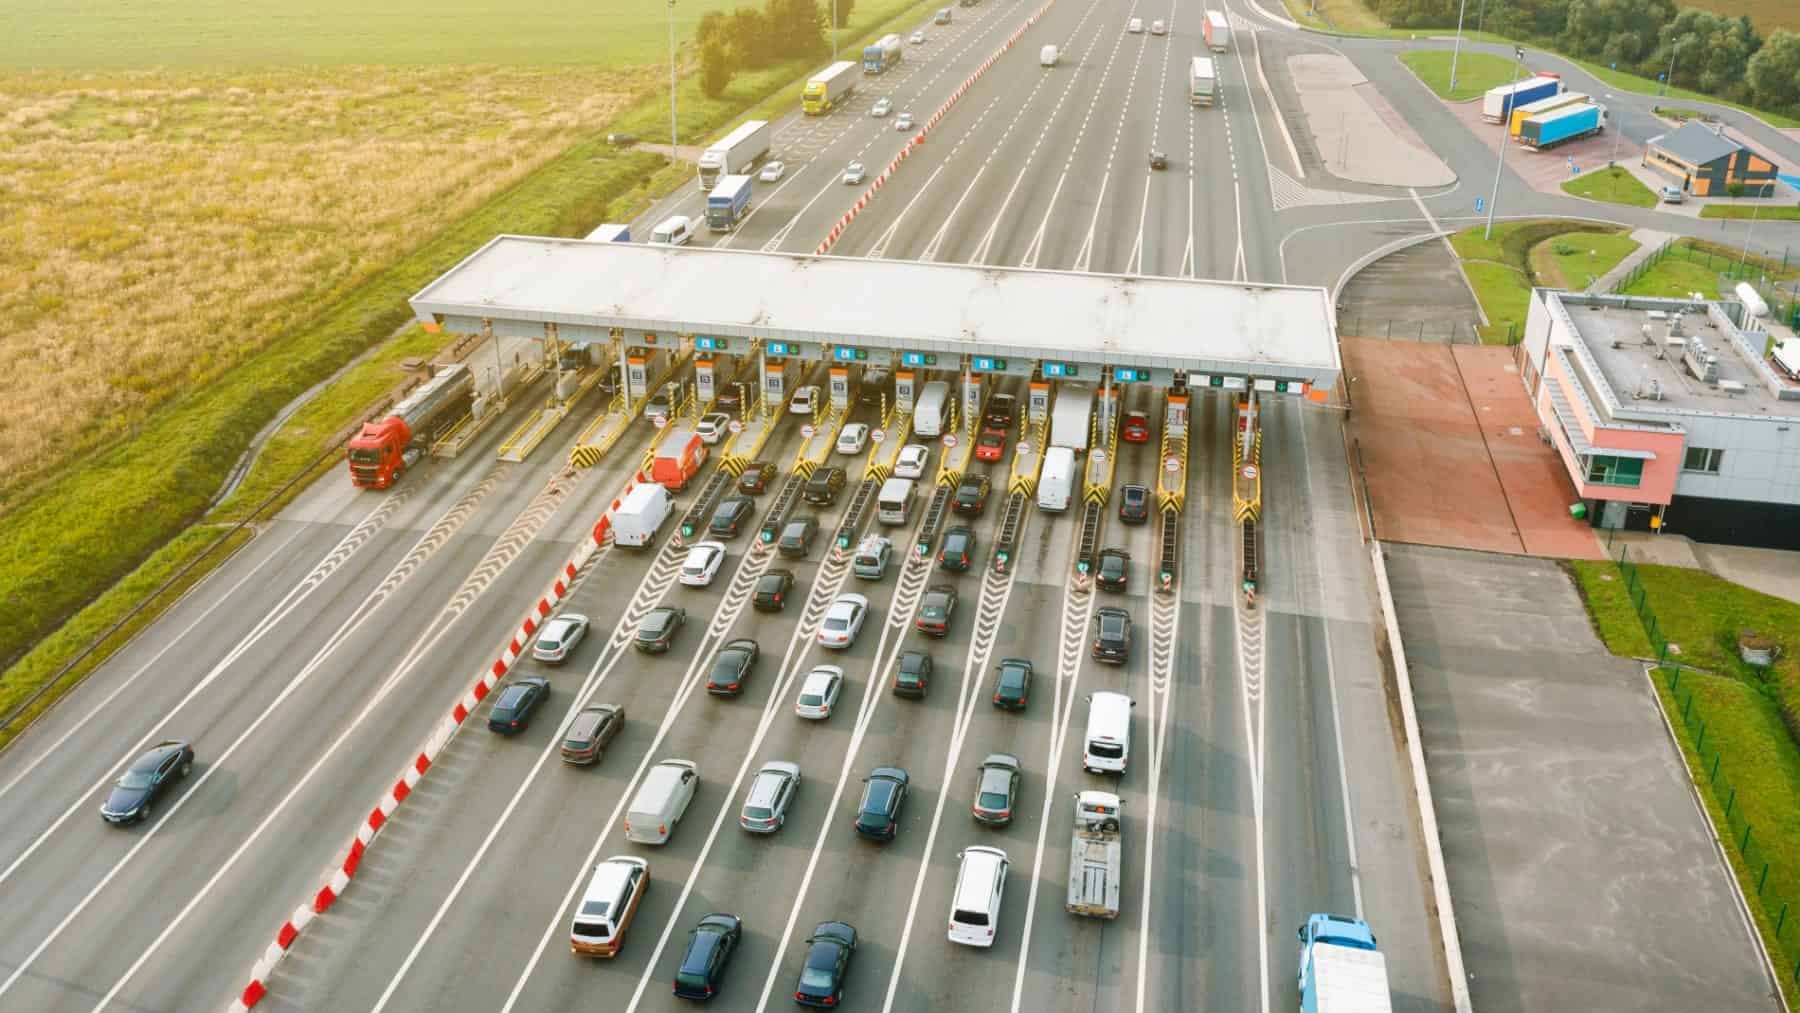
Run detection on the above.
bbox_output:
[230,471,648,1011]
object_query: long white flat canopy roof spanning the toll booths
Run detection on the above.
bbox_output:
[410,236,1341,390]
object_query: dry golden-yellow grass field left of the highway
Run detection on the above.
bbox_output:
[0,67,657,509]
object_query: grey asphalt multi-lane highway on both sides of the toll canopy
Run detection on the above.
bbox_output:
[0,0,1447,1011]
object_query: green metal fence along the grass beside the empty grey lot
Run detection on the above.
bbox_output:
[1607,531,1800,986]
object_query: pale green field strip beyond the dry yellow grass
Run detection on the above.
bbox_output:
[0,0,766,70]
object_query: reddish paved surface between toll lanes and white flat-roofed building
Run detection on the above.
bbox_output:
[1341,338,1600,558]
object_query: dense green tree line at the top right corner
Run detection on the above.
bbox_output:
[1372,0,1800,115]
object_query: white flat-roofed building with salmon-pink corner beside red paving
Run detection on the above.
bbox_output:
[1523,288,1800,549]
